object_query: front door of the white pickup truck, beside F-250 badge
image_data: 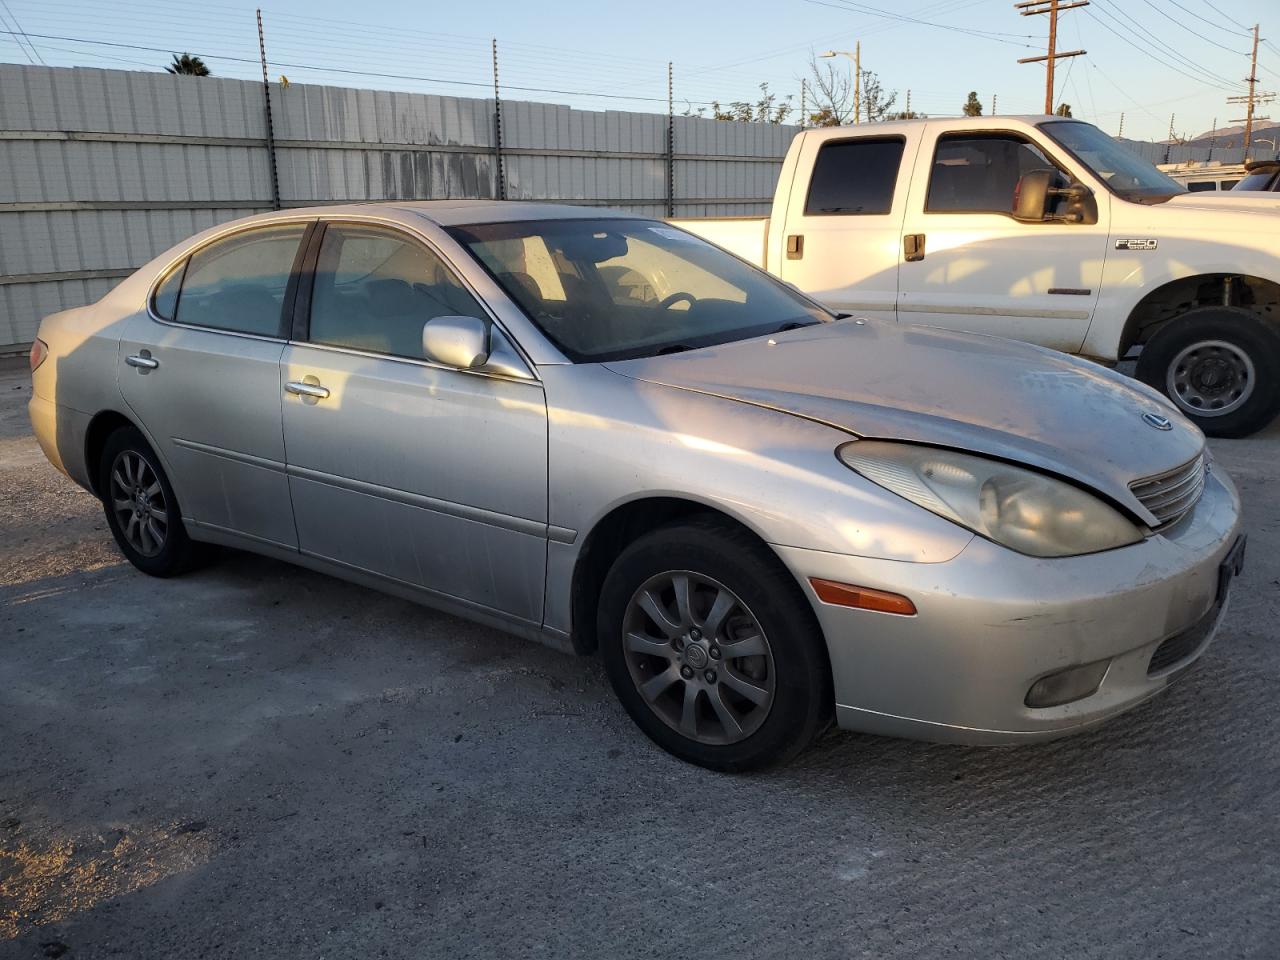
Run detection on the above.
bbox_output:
[897,127,1110,351]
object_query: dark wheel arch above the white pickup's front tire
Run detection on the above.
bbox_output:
[1116,271,1280,360]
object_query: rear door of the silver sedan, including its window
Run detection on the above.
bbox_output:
[119,220,312,548]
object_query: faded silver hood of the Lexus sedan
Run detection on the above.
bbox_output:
[605,320,1204,524]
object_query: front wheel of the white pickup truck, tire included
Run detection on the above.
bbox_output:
[1138,307,1280,436]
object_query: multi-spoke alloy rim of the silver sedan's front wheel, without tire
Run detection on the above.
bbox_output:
[622,571,776,745]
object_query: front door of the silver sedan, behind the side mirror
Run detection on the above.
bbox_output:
[278,223,547,623]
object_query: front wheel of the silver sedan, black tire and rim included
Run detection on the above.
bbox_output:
[598,518,833,771]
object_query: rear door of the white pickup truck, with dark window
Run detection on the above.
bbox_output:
[771,127,920,320]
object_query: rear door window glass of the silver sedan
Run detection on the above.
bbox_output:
[171,223,307,337]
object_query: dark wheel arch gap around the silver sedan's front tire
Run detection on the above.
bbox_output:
[570,495,798,654]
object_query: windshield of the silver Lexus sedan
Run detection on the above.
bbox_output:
[451,219,832,362]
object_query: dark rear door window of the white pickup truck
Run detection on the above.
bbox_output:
[804,137,906,216]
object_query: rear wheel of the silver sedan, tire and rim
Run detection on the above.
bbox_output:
[97,426,202,577]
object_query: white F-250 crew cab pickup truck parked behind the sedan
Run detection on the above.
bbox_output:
[673,116,1280,436]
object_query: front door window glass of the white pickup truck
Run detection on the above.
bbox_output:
[924,133,1065,214]
